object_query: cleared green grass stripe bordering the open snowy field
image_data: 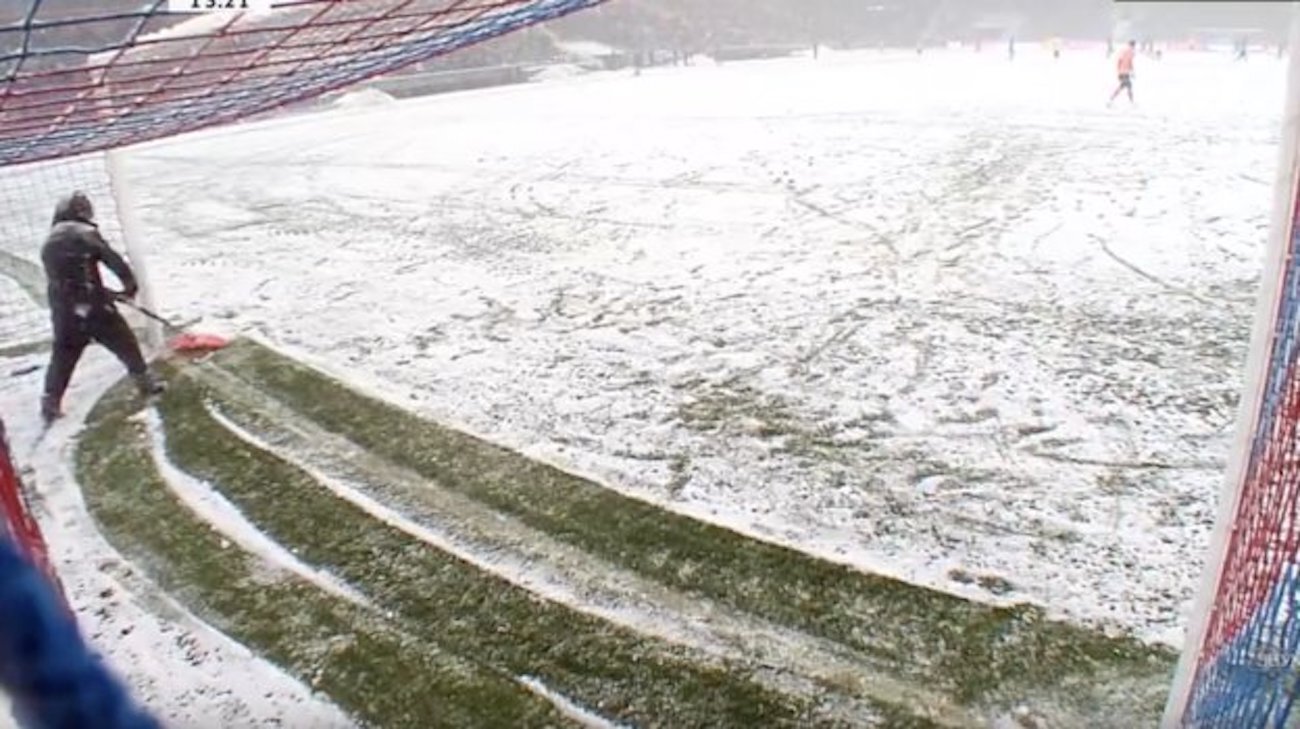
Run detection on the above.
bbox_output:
[213,340,1174,717]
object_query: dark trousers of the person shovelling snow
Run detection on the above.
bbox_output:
[46,307,147,403]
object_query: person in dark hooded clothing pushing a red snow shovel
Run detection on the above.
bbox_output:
[40,191,164,425]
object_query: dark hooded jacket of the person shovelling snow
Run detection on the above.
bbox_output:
[40,198,137,316]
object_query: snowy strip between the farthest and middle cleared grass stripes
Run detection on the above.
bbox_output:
[187,365,983,726]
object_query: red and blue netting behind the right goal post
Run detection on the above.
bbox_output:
[1184,179,1300,729]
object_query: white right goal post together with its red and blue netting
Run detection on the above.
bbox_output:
[1162,4,1300,729]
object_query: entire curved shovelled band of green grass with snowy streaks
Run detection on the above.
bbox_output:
[68,340,1171,726]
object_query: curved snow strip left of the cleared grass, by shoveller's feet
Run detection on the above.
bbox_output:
[0,351,352,729]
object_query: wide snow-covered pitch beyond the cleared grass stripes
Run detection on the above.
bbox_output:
[0,46,1283,716]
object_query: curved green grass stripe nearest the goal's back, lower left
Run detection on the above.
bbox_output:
[77,376,566,729]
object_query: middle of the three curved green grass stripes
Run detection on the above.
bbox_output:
[159,368,837,726]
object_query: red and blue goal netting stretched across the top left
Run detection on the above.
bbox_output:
[0,0,605,165]
